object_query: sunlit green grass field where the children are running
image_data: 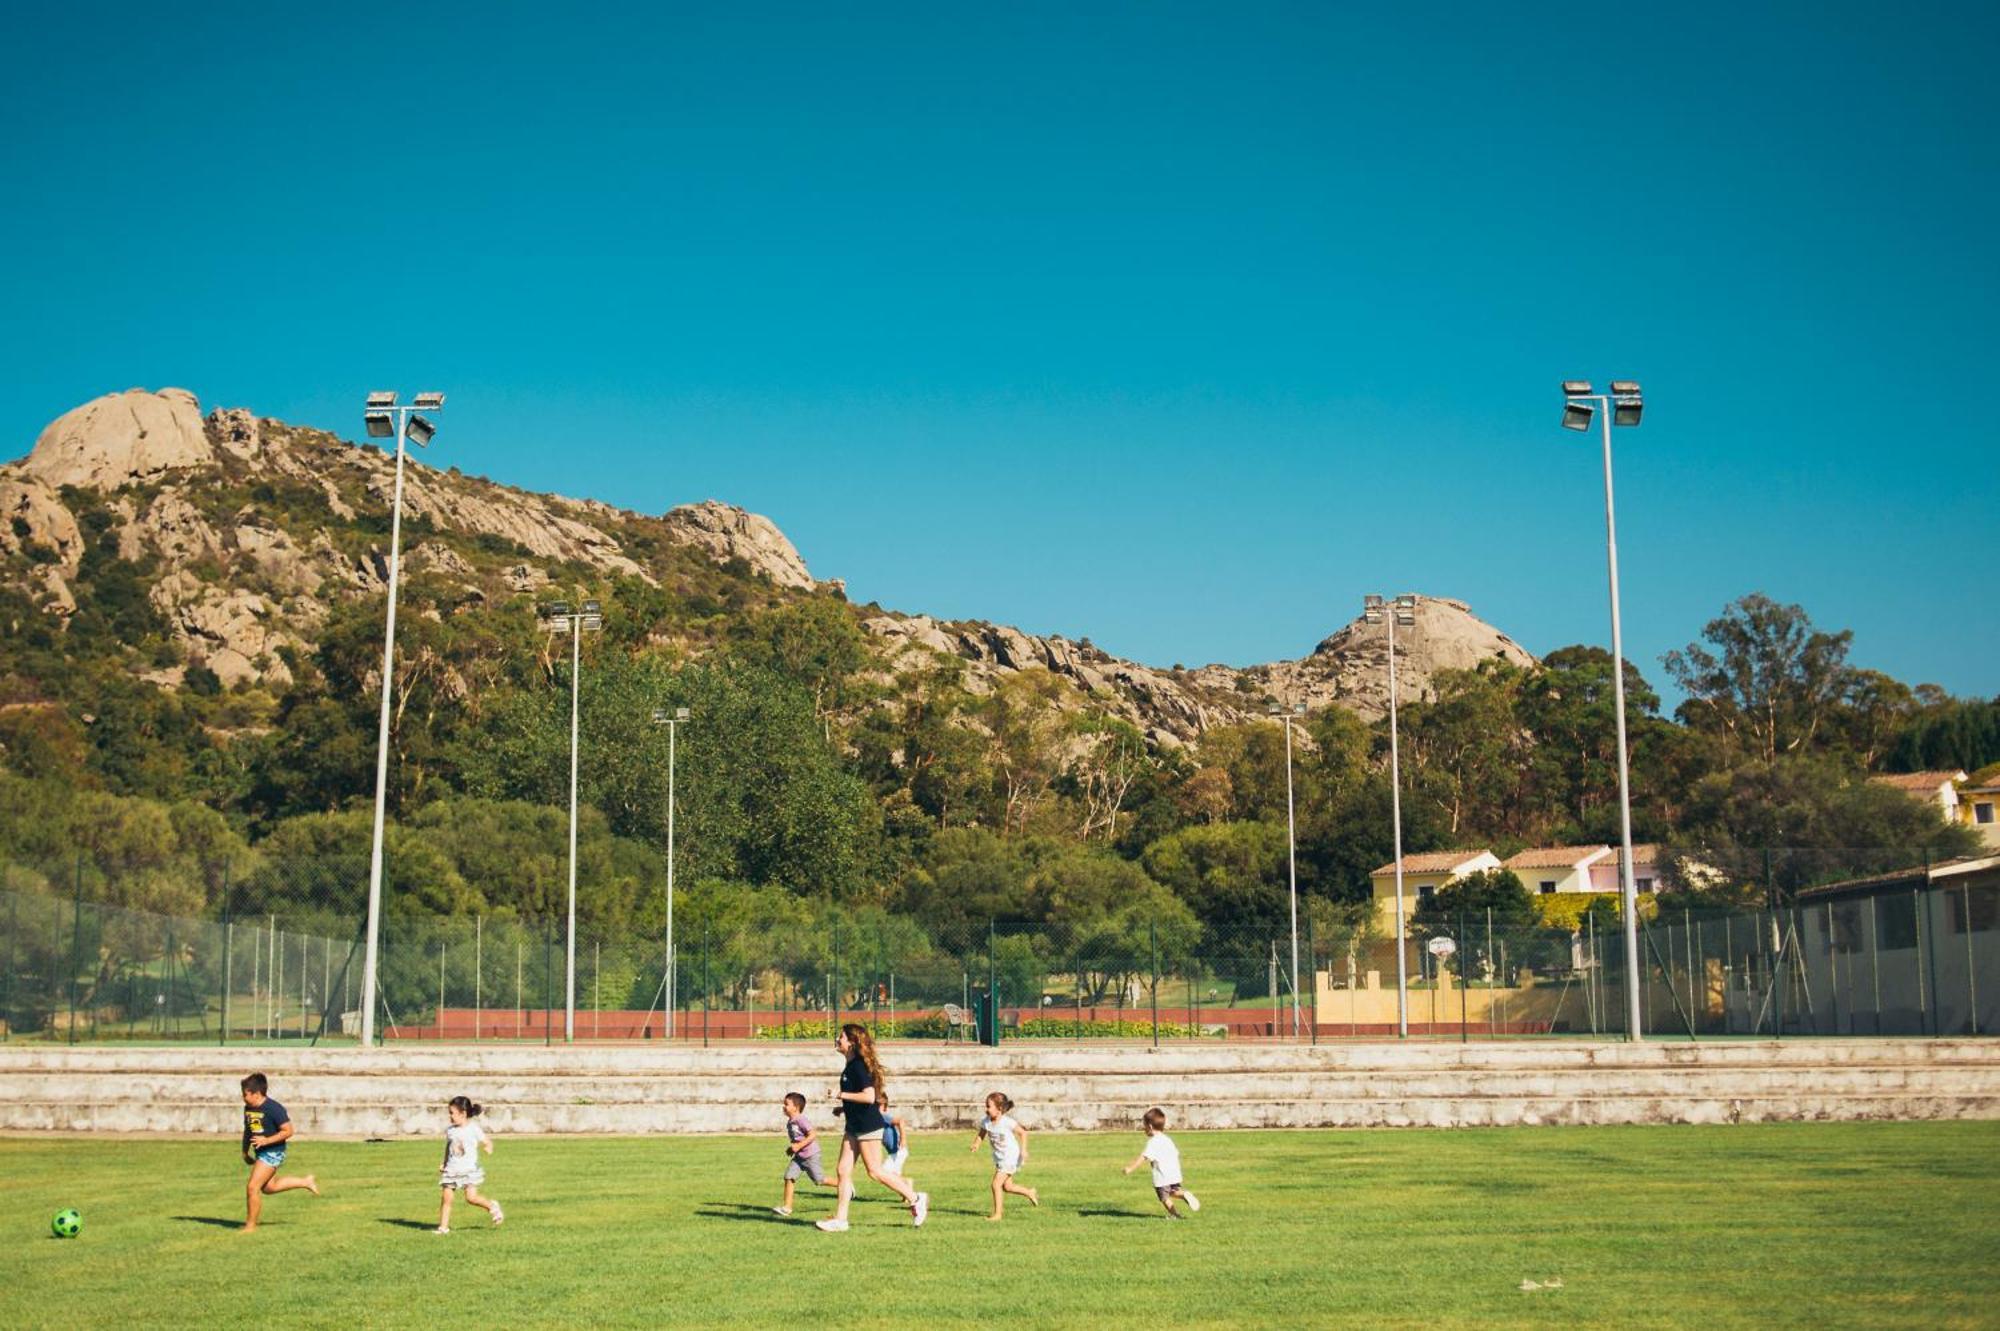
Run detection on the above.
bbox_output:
[0,1115,2000,1331]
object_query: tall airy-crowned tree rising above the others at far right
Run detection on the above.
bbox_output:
[1662,594,1854,763]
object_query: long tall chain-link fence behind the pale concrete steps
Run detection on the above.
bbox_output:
[0,851,2000,1043]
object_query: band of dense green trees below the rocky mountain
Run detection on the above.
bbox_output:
[0,566,2000,955]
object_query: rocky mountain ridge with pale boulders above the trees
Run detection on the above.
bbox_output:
[0,388,1534,745]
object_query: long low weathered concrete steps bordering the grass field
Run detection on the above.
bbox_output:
[0,1039,2000,1137]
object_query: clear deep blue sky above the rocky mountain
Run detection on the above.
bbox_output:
[0,4,2000,695]
